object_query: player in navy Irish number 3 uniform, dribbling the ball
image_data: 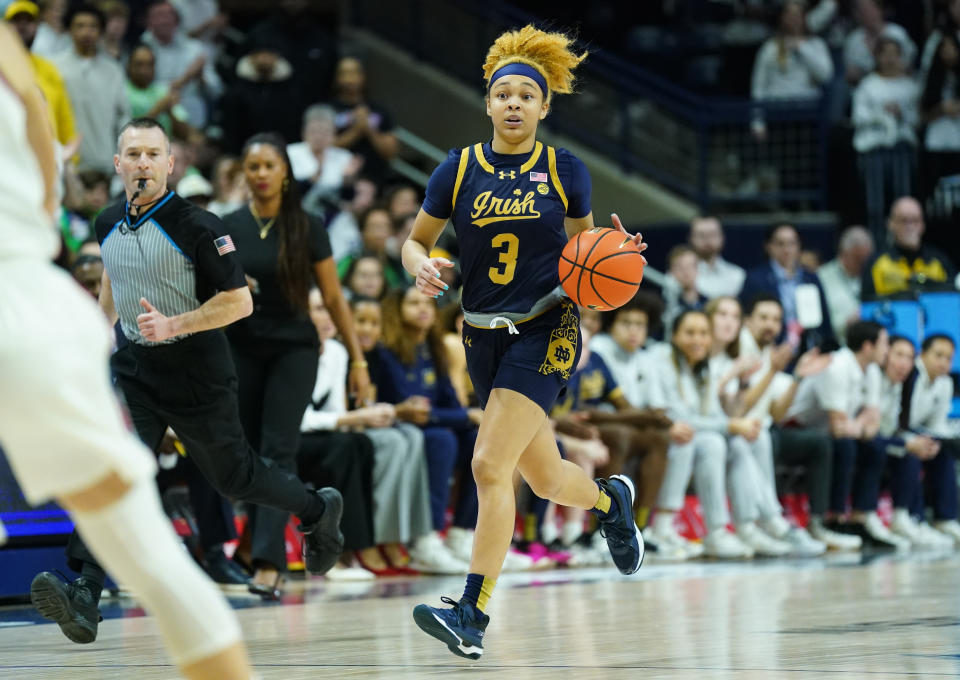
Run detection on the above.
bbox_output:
[402,26,646,659]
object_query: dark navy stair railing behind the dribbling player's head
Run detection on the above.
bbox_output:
[348,0,828,212]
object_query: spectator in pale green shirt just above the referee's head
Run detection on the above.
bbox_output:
[127,44,190,138]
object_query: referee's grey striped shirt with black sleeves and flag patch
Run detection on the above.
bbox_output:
[95,192,246,345]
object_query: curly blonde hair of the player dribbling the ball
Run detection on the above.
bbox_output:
[483,24,587,102]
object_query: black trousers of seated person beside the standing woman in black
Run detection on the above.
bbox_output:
[298,431,374,554]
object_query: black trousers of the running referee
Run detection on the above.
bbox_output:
[67,331,311,568]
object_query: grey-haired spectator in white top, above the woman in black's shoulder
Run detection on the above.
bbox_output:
[287,104,359,194]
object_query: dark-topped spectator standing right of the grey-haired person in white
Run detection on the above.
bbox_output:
[333,57,399,183]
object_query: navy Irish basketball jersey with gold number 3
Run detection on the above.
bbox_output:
[423,142,590,313]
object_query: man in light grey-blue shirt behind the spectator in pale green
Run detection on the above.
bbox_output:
[140,0,222,129]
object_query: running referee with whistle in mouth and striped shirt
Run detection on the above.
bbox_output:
[31,118,343,642]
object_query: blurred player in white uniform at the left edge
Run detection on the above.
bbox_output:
[0,24,251,680]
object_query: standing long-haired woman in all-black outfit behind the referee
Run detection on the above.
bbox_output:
[223,133,370,597]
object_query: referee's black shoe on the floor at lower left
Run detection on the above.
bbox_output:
[30,571,103,645]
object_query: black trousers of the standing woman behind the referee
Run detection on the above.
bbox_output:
[230,340,320,571]
